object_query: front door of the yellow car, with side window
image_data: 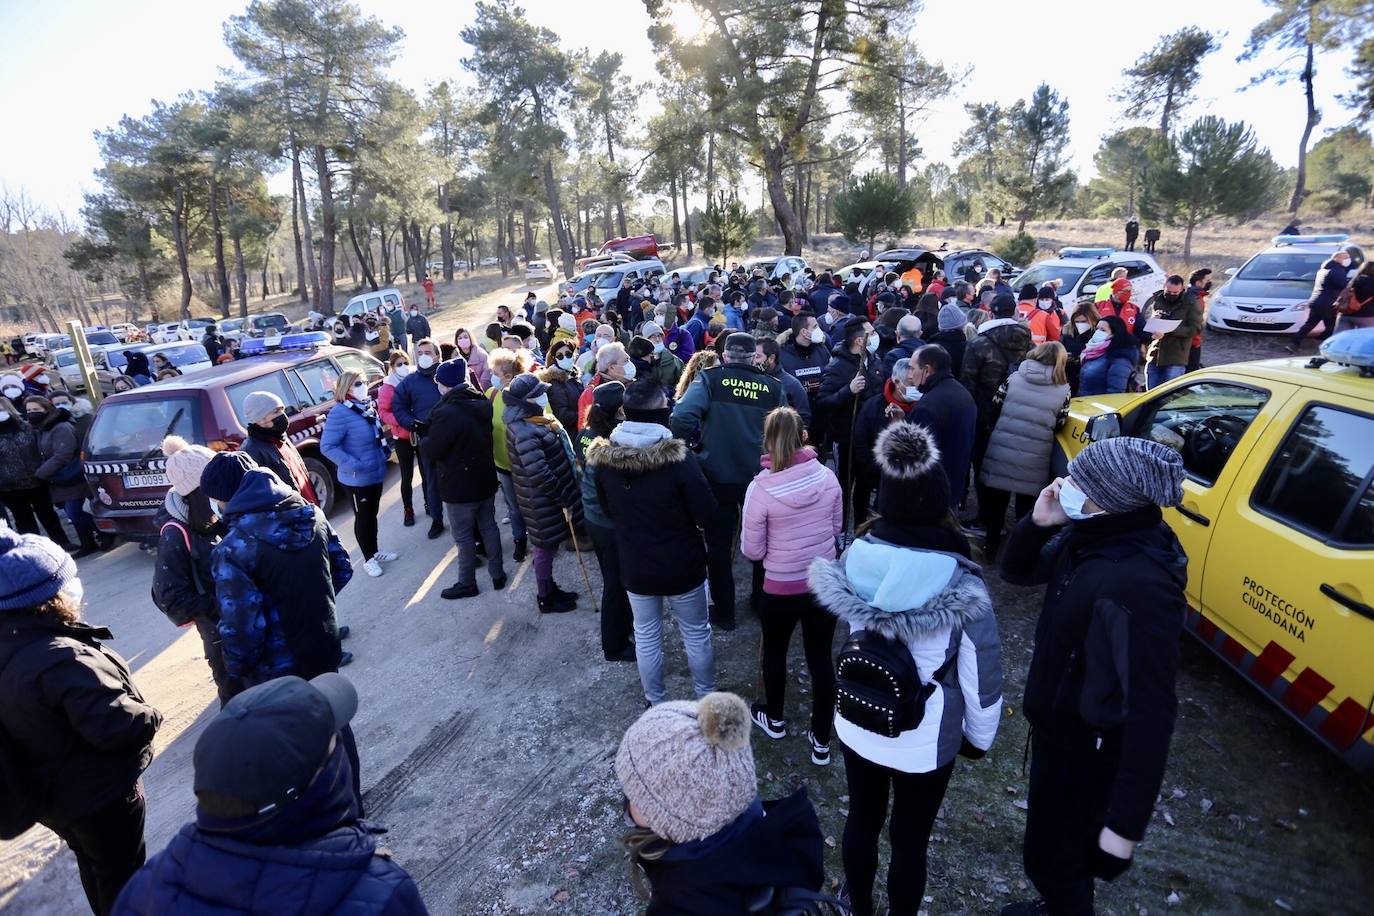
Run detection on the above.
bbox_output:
[1123,375,1297,607]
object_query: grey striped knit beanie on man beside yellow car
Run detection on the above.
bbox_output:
[1069,435,1183,514]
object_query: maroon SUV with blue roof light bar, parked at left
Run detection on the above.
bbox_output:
[82,332,382,540]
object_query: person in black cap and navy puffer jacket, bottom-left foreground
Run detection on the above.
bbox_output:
[111,674,429,916]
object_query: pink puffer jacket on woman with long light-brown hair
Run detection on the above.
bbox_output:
[739,448,844,595]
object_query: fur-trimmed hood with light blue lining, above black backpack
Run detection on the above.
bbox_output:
[809,534,992,643]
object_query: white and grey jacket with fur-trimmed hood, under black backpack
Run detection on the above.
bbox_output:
[811,534,1002,773]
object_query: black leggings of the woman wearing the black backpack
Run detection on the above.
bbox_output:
[842,747,954,916]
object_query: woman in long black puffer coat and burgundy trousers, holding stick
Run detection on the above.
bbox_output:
[504,374,583,614]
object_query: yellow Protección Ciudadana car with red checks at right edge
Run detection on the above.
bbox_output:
[1058,328,1374,775]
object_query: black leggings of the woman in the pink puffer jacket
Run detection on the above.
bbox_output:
[758,592,835,744]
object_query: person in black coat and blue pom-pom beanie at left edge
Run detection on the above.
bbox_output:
[0,529,162,913]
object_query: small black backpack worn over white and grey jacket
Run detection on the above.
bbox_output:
[835,630,959,737]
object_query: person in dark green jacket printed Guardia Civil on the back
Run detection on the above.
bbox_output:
[672,331,787,630]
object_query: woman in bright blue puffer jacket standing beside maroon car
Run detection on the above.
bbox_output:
[320,369,409,578]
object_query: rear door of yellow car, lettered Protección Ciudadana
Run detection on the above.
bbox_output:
[1202,391,1374,754]
